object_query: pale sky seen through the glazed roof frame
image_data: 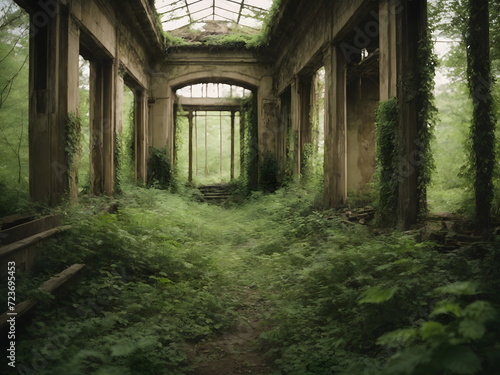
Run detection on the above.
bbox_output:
[155,0,273,31]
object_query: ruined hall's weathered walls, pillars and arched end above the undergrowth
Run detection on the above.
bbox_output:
[5,0,427,227]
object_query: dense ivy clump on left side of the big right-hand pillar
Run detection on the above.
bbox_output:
[376,97,399,223]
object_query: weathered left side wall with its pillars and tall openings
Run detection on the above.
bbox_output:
[16,0,164,204]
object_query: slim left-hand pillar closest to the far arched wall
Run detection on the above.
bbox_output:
[134,89,148,184]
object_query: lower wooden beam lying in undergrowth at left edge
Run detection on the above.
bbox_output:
[0,264,85,331]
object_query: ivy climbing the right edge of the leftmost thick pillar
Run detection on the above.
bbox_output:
[64,113,82,191]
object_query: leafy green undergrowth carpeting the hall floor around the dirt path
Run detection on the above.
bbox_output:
[7,188,500,375]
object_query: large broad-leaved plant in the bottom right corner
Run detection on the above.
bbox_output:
[377,282,500,375]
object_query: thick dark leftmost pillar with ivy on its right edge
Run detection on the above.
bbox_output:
[29,3,79,205]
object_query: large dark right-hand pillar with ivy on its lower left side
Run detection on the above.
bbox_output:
[379,0,427,228]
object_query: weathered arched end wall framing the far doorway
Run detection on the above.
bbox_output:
[154,47,278,174]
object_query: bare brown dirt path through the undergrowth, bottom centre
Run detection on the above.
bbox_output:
[190,288,279,375]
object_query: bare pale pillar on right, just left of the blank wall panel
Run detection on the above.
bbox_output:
[324,45,347,208]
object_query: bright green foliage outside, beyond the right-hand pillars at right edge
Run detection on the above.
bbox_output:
[430,0,500,223]
